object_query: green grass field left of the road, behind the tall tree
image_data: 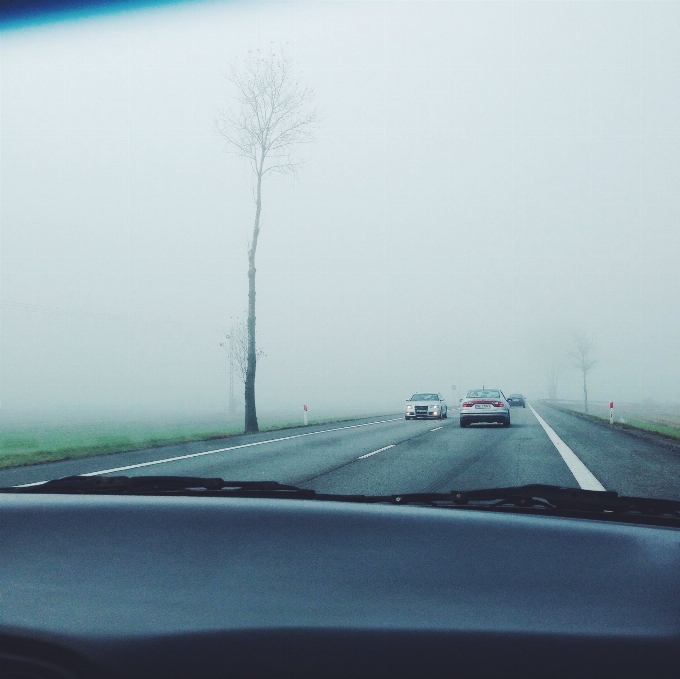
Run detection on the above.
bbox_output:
[0,413,394,468]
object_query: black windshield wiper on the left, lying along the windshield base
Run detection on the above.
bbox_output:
[5,476,316,498]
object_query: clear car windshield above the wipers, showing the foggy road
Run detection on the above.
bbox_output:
[0,0,680,508]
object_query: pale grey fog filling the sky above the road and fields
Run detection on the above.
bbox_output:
[0,2,680,420]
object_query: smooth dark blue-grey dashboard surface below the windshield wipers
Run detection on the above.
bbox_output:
[0,495,680,678]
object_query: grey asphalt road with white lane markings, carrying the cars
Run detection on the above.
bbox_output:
[0,405,680,500]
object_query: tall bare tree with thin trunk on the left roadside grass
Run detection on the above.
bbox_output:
[217,51,318,433]
